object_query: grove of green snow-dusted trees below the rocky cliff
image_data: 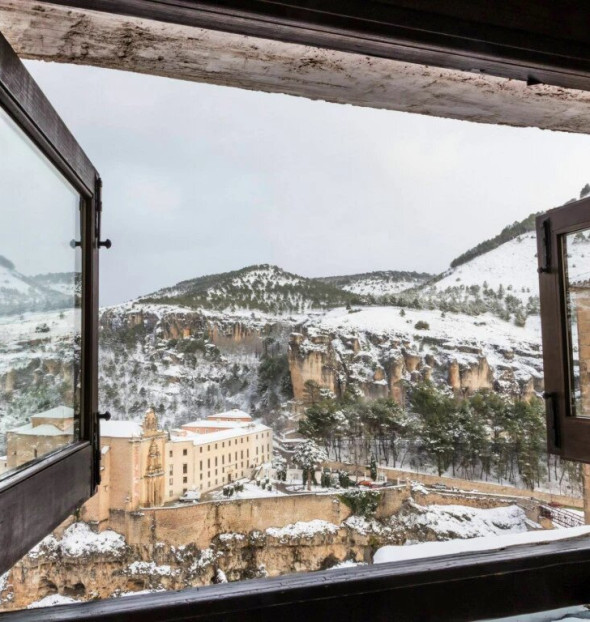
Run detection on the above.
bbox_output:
[299,383,564,489]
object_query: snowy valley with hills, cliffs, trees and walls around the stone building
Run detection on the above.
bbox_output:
[0,193,590,609]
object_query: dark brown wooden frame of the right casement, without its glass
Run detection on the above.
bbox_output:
[536,198,590,463]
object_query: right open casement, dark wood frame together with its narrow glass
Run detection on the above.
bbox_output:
[537,198,590,462]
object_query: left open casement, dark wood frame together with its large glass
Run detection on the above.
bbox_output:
[0,29,100,572]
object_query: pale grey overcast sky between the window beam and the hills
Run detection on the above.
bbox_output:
[20,61,590,305]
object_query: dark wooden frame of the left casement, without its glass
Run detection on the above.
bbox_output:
[0,29,100,574]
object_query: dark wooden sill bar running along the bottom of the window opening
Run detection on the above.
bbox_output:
[0,537,590,622]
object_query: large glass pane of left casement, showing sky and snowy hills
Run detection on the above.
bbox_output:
[0,109,81,479]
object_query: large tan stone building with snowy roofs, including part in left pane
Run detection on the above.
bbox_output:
[6,406,273,523]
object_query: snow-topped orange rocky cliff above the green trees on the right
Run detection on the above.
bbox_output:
[289,307,543,403]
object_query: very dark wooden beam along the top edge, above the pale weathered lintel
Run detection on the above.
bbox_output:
[40,0,590,90]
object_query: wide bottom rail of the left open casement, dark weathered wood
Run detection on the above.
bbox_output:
[0,442,93,572]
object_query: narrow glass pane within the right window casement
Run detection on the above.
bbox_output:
[563,231,590,417]
